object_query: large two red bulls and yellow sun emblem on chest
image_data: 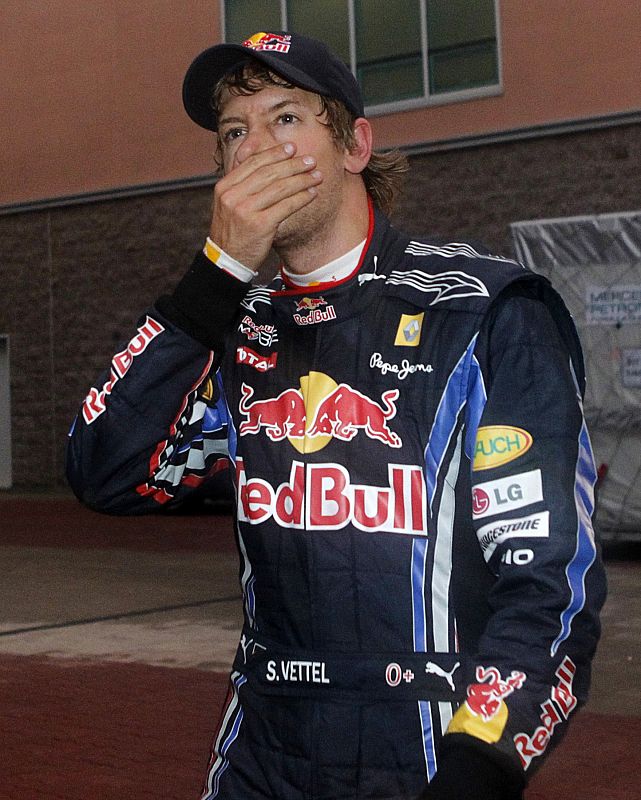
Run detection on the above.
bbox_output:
[238,372,402,453]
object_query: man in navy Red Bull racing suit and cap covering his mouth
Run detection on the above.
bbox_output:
[68,32,604,800]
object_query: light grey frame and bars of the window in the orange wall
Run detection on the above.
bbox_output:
[220,0,503,117]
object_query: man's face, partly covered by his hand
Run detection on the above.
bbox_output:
[218,85,345,248]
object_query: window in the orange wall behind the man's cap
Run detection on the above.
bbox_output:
[223,0,500,114]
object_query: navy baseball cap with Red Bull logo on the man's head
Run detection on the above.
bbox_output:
[183,31,365,131]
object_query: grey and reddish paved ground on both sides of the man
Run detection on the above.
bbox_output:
[0,493,641,800]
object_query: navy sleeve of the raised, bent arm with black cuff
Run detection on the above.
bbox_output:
[67,253,250,514]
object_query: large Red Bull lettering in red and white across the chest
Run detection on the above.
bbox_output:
[236,458,427,535]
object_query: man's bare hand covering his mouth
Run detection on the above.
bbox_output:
[209,142,322,269]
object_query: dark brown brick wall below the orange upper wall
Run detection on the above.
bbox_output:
[0,125,641,488]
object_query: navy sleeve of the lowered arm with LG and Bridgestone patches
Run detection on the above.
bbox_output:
[430,295,605,798]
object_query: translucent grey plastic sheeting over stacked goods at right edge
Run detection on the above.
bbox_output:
[510,211,641,537]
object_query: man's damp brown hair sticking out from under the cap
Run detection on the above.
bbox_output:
[212,60,409,214]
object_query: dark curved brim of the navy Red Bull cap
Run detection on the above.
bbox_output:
[183,44,327,131]
